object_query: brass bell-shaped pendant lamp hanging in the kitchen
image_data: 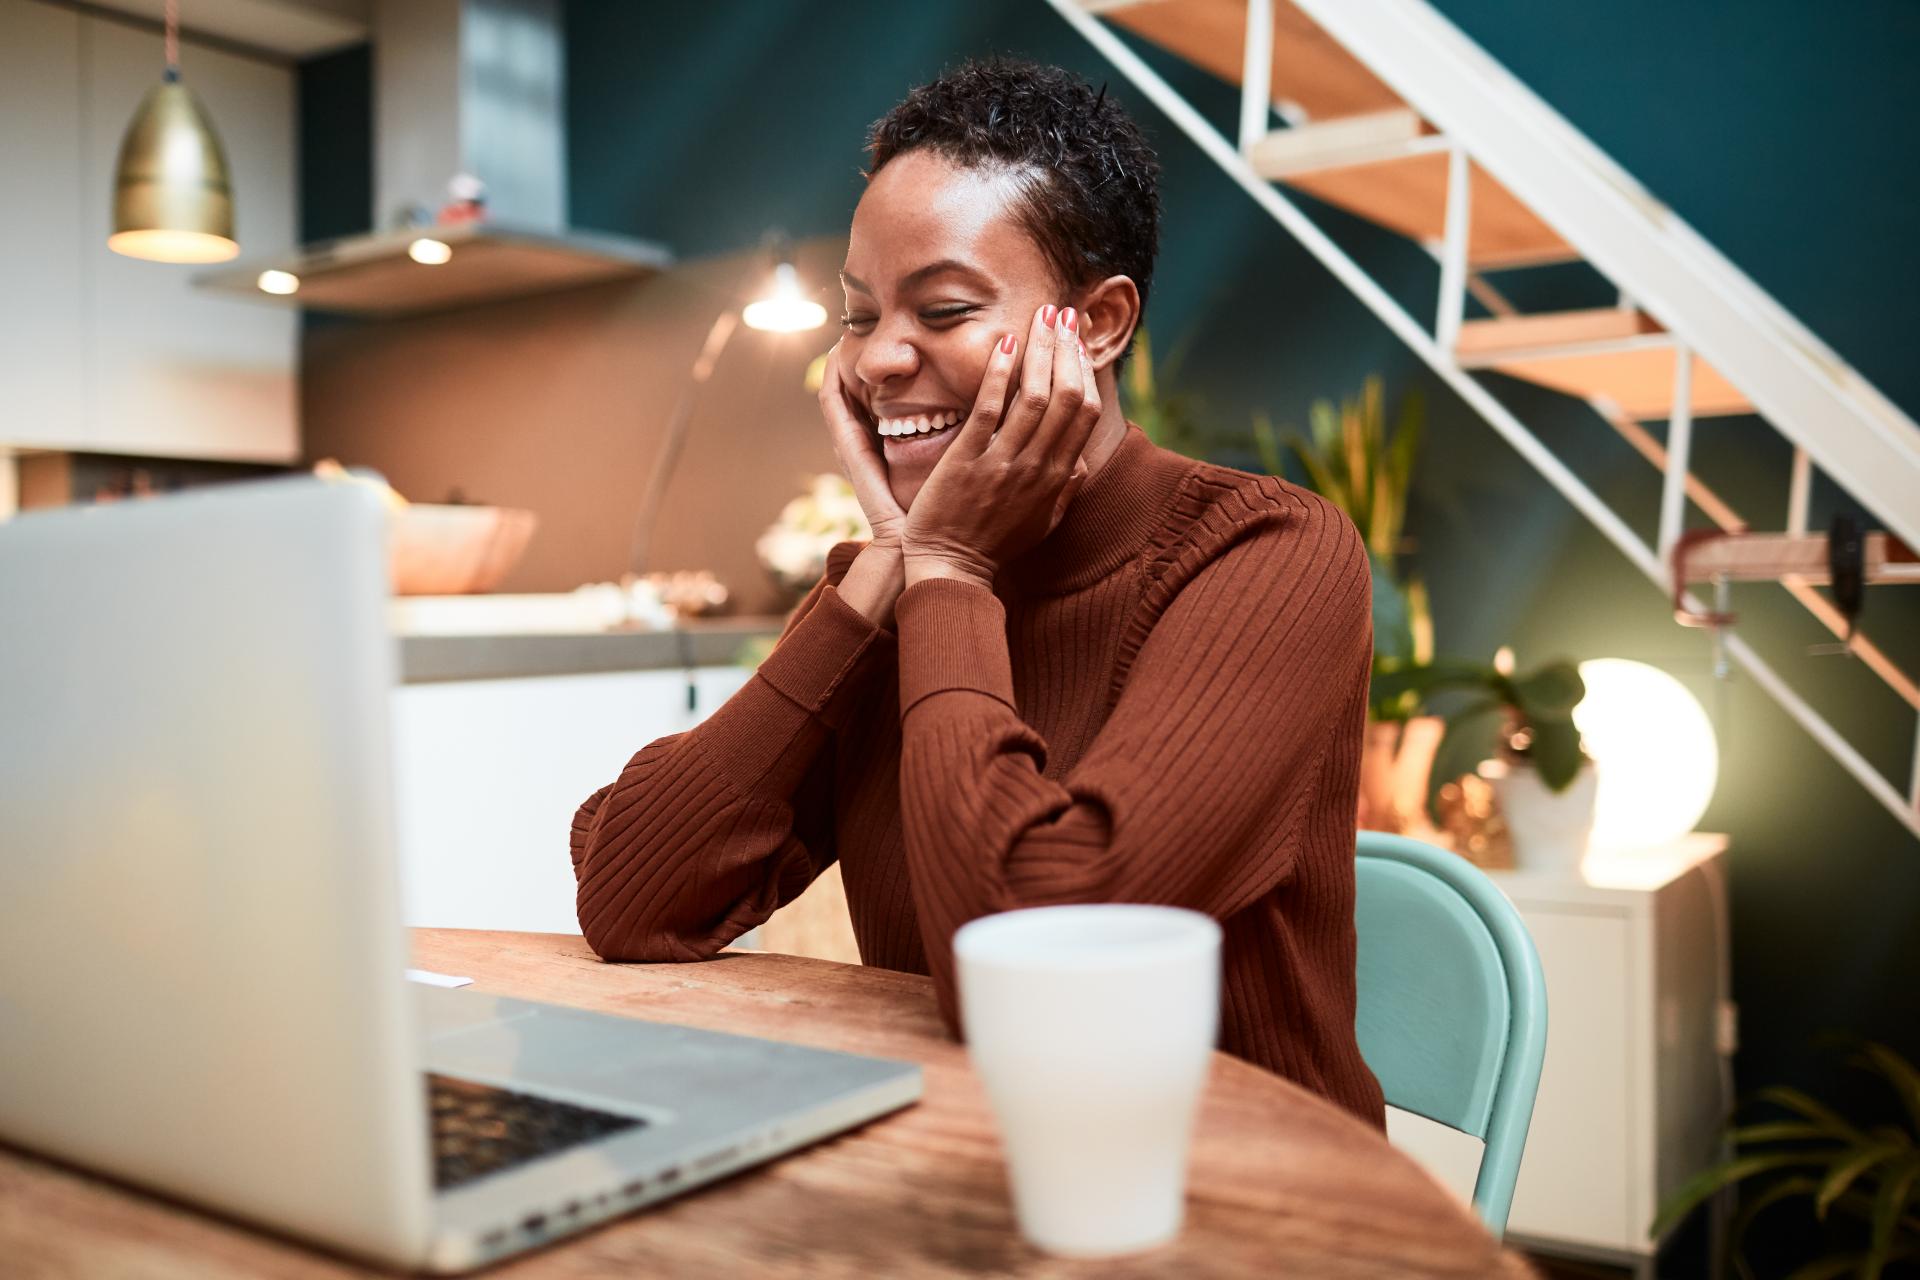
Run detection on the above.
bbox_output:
[108,0,240,263]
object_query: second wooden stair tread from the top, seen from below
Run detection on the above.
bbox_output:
[1281,140,1580,271]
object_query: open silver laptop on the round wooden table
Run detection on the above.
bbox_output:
[0,480,920,1270]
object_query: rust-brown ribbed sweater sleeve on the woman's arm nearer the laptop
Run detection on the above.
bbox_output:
[570,583,893,960]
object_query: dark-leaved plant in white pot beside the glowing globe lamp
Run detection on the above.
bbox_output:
[1371,658,1596,871]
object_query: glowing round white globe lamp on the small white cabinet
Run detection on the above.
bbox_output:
[1572,658,1720,850]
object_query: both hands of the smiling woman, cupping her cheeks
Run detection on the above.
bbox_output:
[820,307,1100,626]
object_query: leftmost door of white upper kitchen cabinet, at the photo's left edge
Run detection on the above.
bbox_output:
[0,0,86,445]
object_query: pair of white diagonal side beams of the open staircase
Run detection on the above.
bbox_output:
[1046,0,1920,837]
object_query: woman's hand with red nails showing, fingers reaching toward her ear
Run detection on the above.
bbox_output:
[904,307,1100,589]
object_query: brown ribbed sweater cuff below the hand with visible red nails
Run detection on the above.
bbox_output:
[893,578,1018,718]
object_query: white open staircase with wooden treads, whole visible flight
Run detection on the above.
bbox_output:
[1048,0,1920,837]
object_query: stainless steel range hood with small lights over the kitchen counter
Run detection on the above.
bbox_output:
[194,0,672,315]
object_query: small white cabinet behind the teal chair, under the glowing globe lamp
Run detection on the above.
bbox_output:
[1388,835,1732,1274]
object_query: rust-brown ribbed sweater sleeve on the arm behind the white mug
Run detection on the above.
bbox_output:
[897,507,1371,1032]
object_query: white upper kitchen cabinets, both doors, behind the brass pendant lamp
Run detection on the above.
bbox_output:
[0,0,300,462]
